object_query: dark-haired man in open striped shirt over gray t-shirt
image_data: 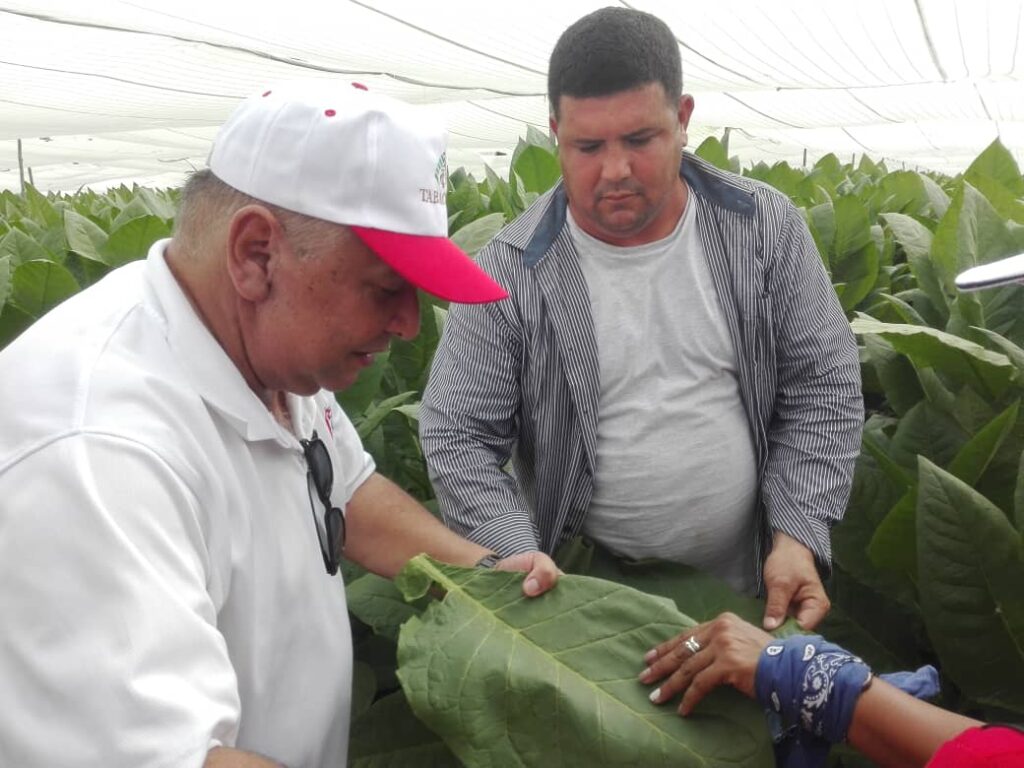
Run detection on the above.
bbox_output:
[421,8,863,629]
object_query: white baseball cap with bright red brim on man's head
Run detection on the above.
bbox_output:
[209,80,508,303]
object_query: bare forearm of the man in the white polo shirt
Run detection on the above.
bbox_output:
[345,474,487,579]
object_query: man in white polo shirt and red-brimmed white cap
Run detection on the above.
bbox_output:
[0,83,556,767]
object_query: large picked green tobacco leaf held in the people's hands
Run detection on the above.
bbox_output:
[396,555,772,768]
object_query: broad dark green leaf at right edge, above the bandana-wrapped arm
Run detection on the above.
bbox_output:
[918,459,1024,714]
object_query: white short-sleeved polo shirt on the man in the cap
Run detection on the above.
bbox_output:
[0,241,374,768]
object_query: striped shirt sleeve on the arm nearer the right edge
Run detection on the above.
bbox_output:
[762,201,864,567]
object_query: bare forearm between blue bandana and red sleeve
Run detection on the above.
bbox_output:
[847,679,981,768]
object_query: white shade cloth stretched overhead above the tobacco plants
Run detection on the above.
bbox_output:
[0,0,1024,191]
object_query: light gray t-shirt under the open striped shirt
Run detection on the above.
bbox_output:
[568,202,757,593]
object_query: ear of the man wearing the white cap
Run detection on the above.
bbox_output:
[227,205,285,302]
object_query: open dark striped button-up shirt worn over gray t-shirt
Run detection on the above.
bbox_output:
[420,154,863,588]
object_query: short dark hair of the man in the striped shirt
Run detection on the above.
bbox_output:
[548,7,683,118]
